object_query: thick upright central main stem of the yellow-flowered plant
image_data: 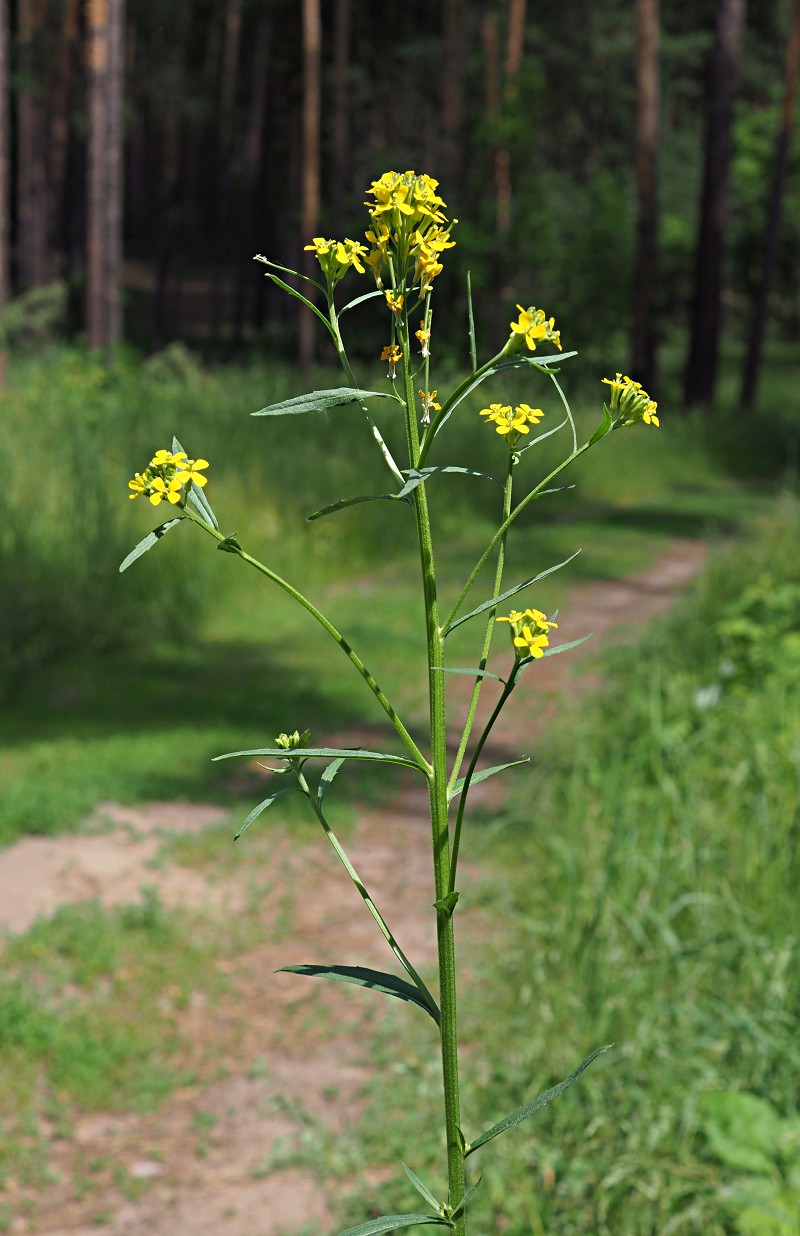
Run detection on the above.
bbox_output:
[403,319,466,1236]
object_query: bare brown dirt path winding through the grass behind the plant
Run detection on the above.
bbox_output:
[0,540,705,1236]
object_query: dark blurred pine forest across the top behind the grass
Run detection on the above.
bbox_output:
[0,0,800,407]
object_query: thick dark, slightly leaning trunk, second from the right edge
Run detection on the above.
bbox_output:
[684,0,746,405]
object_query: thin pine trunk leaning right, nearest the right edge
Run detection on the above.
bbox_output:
[739,0,800,412]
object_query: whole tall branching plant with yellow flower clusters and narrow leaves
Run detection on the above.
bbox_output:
[121,172,658,1236]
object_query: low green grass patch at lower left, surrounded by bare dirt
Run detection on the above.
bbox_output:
[0,890,236,1184]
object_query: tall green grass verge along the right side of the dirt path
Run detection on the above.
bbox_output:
[289,508,800,1236]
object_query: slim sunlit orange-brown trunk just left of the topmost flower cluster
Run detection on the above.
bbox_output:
[298,0,323,368]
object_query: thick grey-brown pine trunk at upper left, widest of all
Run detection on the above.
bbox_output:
[87,0,125,351]
